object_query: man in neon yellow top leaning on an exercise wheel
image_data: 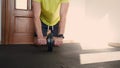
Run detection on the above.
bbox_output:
[33,0,69,46]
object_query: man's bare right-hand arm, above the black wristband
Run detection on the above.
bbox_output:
[59,3,69,34]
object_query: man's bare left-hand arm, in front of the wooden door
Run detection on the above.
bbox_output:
[32,1,43,39]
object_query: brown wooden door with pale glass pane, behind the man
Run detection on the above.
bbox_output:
[3,0,34,44]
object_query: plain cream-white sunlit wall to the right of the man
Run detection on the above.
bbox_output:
[65,0,120,48]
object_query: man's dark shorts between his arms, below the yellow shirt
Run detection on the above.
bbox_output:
[34,22,59,37]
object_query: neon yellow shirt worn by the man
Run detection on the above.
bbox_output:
[33,0,69,26]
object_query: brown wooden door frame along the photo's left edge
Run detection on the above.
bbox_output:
[1,0,11,44]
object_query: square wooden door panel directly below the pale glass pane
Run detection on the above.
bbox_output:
[15,17,33,33]
